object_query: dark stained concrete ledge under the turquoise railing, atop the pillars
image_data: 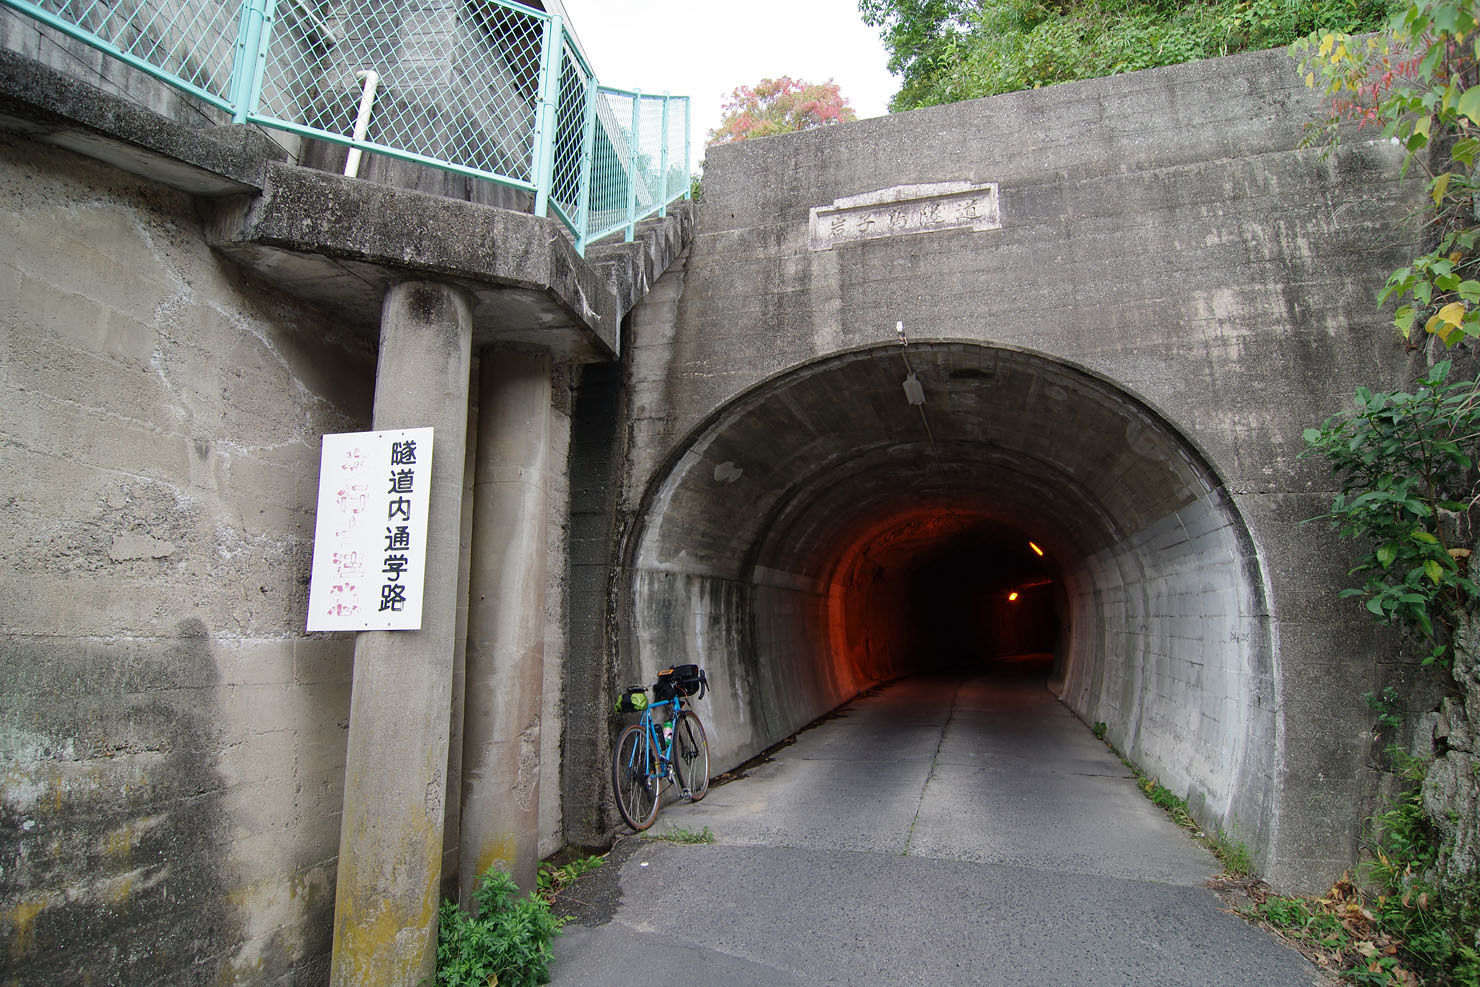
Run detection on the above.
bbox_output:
[0,50,693,363]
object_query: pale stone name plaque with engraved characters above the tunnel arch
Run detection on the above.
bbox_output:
[807,182,1002,250]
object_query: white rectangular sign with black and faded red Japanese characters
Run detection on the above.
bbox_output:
[308,428,432,630]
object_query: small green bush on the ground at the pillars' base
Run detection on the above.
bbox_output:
[437,867,564,987]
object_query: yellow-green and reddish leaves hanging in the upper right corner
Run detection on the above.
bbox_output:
[1291,0,1480,345]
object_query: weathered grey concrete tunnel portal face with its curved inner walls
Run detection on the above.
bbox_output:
[589,44,1421,886]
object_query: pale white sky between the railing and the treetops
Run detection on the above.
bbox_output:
[562,0,898,164]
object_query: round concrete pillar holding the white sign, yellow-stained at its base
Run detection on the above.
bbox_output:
[332,281,472,987]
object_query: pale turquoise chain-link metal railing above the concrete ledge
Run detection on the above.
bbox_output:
[0,0,690,253]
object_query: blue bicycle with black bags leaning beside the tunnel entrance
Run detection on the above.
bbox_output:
[611,664,709,832]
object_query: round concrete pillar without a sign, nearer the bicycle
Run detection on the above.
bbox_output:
[459,349,551,900]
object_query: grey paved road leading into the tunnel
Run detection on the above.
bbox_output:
[551,657,1328,987]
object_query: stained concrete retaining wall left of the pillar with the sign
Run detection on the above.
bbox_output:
[0,138,374,984]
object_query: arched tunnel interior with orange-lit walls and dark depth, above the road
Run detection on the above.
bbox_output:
[617,342,1280,848]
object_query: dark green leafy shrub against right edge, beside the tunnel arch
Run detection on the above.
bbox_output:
[1302,363,1480,664]
